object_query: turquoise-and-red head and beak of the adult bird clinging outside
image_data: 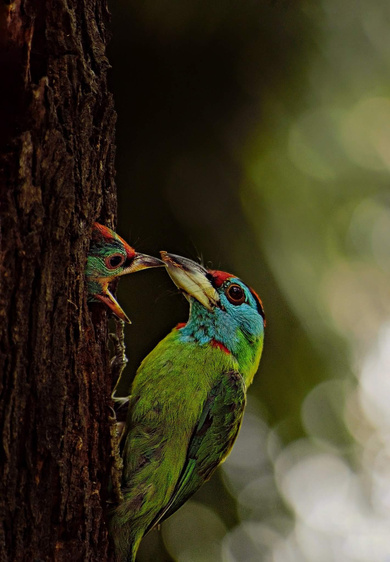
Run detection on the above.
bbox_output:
[161,252,265,384]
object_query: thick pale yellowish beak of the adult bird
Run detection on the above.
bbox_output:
[160,252,219,310]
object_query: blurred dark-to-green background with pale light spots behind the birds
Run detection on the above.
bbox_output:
[109,0,390,562]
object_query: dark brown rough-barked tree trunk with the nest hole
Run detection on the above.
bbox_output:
[0,0,116,562]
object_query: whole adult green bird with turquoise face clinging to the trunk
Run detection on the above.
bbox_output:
[110,252,265,562]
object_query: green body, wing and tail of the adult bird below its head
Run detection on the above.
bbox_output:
[110,333,246,562]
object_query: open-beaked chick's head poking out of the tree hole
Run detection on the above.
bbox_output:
[85,222,163,322]
